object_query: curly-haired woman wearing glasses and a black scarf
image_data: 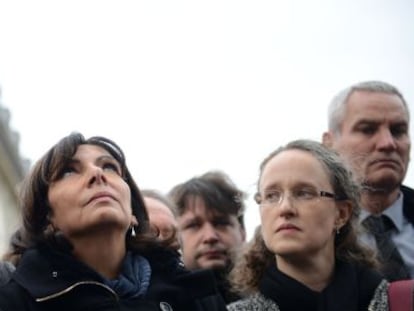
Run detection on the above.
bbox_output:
[228,140,388,311]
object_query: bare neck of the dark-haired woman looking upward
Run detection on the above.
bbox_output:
[72,234,126,279]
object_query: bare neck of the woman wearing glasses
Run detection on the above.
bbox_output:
[277,256,335,292]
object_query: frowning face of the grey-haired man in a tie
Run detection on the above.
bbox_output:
[329,91,411,190]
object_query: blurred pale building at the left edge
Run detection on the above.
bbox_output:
[0,89,30,255]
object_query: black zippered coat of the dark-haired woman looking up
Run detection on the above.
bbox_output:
[0,247,226,311]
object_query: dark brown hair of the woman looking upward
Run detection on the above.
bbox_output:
[6,133,167,258]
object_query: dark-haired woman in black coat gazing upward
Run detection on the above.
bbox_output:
[0,133,225,311]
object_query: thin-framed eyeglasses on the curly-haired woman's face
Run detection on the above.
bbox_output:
[254,189,346,210]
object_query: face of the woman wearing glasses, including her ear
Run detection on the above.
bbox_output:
[259,150,349,261]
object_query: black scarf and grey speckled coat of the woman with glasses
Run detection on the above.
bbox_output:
[228,263,388,311]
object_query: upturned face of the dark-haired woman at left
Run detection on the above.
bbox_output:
[48,145,136,241]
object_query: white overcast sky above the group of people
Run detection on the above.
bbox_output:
[0,0,414,239]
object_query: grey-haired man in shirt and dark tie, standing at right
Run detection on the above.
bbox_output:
[322,81,414,281]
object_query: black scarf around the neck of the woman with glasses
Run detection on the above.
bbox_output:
[259,262,382,311]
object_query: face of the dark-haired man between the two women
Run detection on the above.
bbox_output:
[178,196,245,270]
